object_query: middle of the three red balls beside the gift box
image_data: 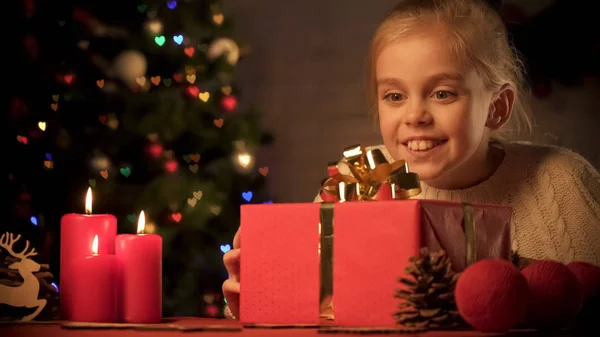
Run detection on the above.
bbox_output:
[521,260,583,329]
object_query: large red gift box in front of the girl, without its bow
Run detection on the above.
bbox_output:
[239,200,511,326]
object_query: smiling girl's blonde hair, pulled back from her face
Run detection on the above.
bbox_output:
[368,0,532,138]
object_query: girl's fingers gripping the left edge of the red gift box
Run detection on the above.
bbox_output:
[223,229,241,319]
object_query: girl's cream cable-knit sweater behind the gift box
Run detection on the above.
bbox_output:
[315,142,600,266]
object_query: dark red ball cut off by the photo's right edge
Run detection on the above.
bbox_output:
[567,261,600,332]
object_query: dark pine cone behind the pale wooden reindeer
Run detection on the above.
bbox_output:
[0,249,60,321]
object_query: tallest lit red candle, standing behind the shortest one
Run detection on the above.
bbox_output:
[59,188,117,320]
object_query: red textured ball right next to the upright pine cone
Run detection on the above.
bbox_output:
[454,259,529,332]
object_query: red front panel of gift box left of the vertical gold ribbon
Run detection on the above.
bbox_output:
[239,203,320,324]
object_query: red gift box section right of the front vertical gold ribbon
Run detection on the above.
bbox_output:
[333,200,511,326]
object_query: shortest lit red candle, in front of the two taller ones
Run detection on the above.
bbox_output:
[71,235,118,323]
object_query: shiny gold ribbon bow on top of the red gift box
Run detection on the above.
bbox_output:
[321,145,421,202]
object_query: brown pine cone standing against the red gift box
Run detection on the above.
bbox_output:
[394,247,466,330]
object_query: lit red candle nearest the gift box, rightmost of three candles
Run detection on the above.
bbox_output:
[115,211,162,323]
